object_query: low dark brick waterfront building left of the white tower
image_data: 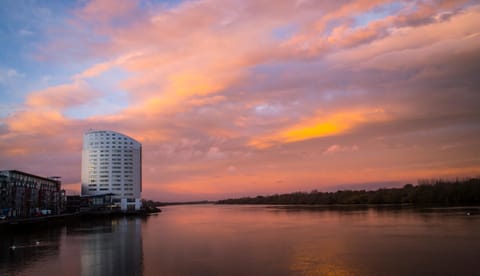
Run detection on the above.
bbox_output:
[0,170,65,217]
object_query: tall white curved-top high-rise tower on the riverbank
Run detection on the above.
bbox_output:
[82,130,142,211]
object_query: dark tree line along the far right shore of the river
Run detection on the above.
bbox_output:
[217,178,480,205]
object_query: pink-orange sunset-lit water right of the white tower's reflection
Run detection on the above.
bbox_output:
[144,206,480,275]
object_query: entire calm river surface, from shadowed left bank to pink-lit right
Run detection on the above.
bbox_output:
[0,205,480,276]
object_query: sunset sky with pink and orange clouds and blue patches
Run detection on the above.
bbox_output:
[0,0,480,201]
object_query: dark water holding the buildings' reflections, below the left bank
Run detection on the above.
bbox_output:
[0,218,145,276]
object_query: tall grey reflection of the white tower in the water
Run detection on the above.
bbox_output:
[81,218,143,276]
